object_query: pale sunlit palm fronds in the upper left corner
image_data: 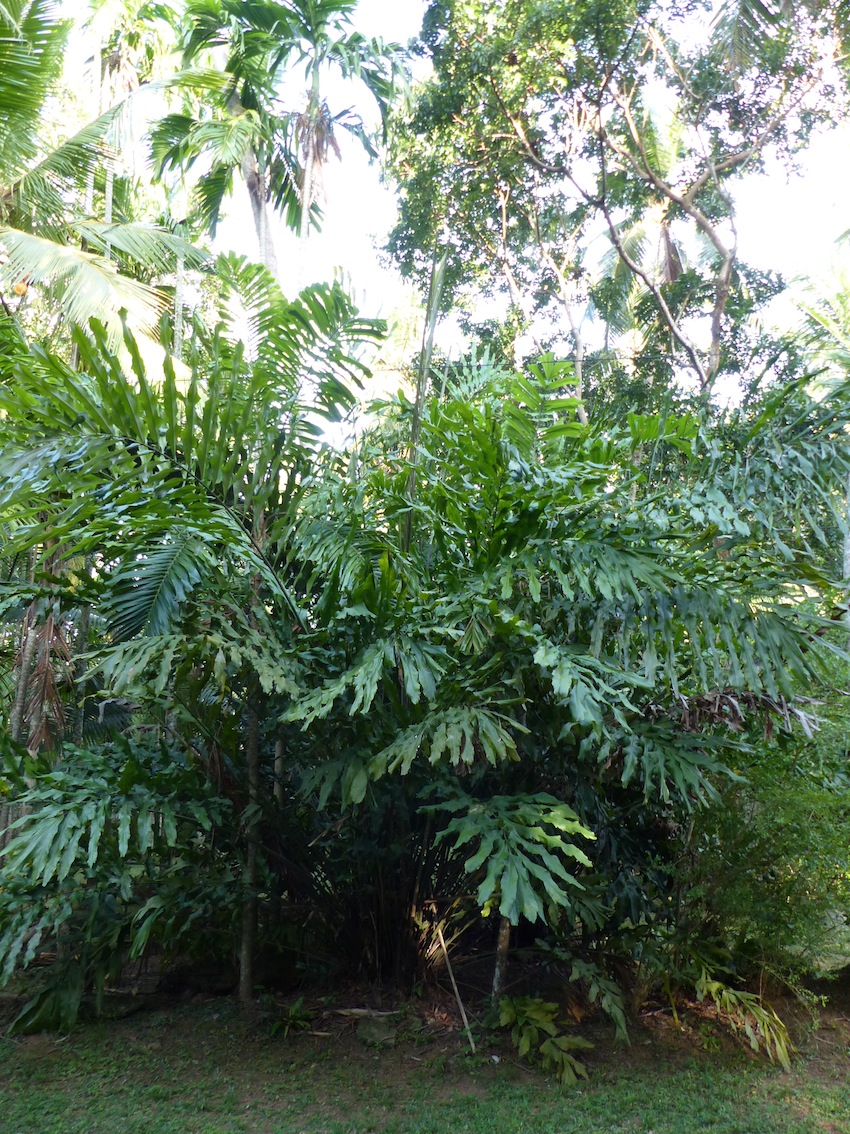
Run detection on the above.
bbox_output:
[0,0,198,337]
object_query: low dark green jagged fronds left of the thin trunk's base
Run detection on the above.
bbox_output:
[0,738,236,1030]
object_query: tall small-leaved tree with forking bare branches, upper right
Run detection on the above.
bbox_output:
[389,0,847,385]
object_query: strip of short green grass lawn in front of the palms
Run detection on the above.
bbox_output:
[0,1000,850,1134]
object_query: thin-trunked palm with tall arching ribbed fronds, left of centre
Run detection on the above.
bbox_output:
[0,256,382,999]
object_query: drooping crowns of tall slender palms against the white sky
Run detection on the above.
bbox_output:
[151,0,396,274]
